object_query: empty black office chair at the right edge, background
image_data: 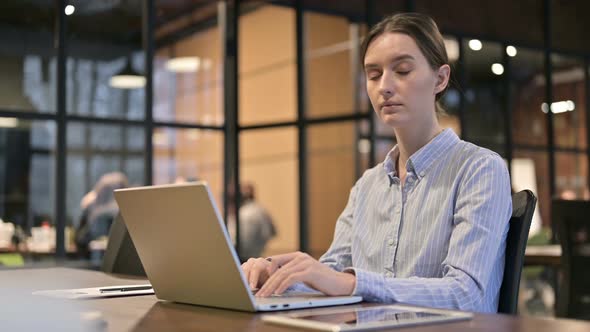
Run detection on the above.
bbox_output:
[551,200,590,320]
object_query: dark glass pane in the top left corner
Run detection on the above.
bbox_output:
[0,1,57,113]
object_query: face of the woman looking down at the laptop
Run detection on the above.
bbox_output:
[364,32,450,128]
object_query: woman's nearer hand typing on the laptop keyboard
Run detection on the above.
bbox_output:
[254,252,356,297]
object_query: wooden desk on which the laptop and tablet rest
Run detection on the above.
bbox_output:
[0,268,590,332]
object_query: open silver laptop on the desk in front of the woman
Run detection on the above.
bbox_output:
[110,182,362,312]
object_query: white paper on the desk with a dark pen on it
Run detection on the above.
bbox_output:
[33,284,154,299]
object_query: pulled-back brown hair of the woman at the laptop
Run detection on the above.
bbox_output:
[361,13,449,104]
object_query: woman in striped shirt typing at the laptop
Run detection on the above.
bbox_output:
[242,14,512,312]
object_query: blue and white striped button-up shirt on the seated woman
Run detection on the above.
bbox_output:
[320,129,512,312]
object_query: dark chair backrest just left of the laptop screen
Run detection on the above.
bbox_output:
[101,214,145,277]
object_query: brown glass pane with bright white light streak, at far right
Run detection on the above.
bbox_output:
[543,54,587,149]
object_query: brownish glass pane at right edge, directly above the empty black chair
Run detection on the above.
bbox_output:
[555,152,590,200]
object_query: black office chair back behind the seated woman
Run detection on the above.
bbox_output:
[498,190,537,315]
